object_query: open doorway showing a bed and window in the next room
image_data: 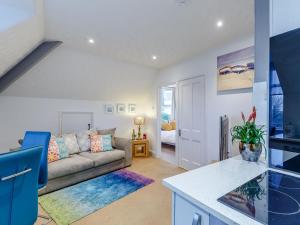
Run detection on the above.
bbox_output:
[159,84,177,164]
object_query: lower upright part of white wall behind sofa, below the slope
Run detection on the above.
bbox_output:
[0,96,155,152]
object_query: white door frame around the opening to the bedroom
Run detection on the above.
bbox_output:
[156,81,179,166]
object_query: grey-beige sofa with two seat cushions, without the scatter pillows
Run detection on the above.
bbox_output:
[39,137,132,195]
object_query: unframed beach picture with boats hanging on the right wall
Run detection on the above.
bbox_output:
[217,46,254,91]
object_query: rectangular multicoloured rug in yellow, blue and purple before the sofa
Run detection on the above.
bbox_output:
[39,169,154,225]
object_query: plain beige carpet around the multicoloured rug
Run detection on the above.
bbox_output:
[36,158,184,225]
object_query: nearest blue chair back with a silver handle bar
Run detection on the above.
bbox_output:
[0,147,42,225]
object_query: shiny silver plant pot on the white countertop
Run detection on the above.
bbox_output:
[239,142,262,162]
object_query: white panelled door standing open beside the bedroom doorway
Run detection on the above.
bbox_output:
[178,76,206,170]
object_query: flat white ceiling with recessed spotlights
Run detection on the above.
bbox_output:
[45,0,254,68]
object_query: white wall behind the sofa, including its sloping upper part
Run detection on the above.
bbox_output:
[0,46,157,151]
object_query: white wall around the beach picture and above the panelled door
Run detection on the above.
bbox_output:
[156,37,254,162]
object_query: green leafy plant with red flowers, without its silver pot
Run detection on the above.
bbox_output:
[231,107,266,148]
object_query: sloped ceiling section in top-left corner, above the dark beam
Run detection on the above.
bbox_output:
[0,0,44,77]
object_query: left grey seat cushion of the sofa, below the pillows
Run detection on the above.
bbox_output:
[48,155,94,179]
